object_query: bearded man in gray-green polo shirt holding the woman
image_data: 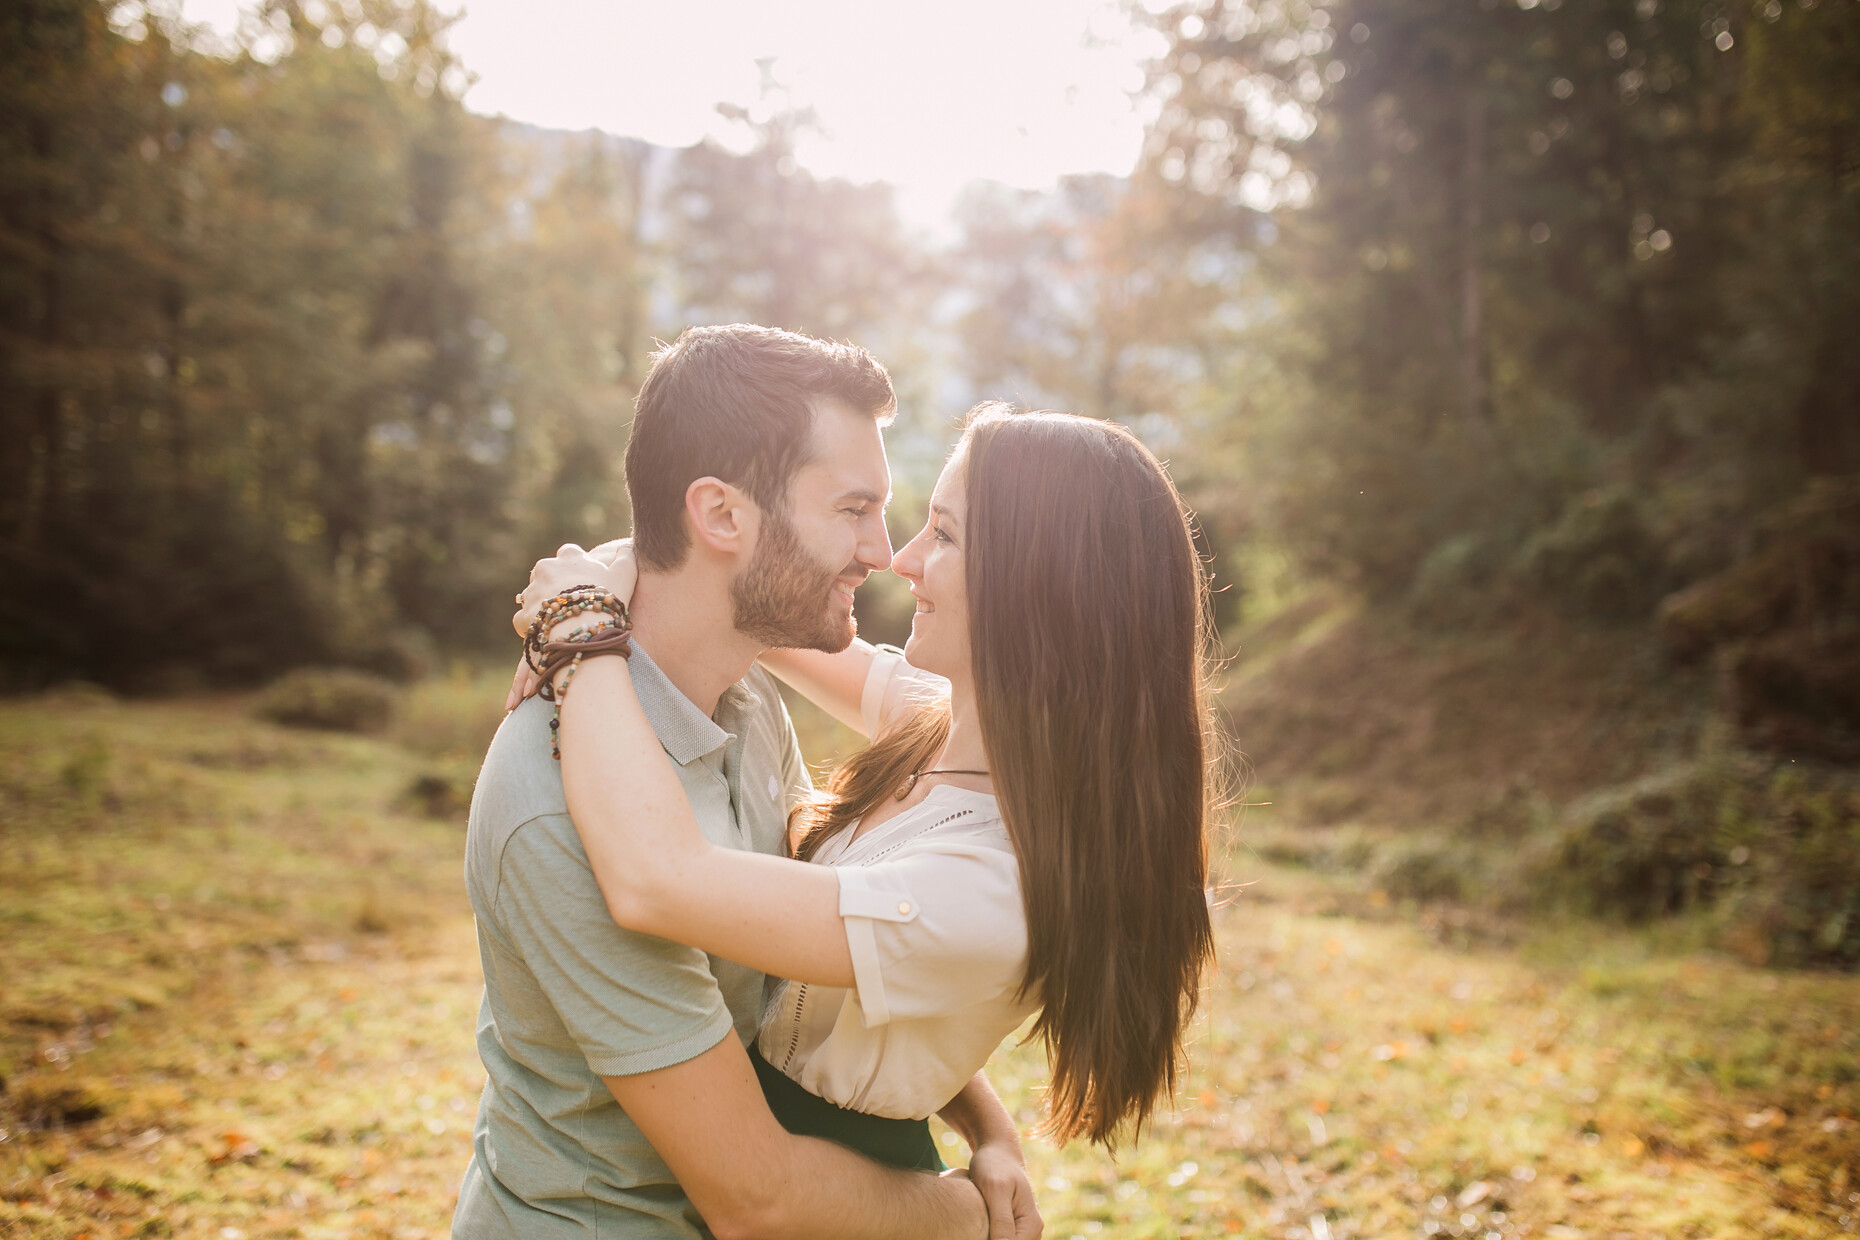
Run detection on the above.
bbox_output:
[452,325,1017,1240]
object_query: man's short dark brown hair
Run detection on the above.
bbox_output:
[627,323,897,571]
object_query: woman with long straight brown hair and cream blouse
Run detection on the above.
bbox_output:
[525,405,1213,1166]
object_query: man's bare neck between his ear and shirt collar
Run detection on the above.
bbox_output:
[627,561,761,716]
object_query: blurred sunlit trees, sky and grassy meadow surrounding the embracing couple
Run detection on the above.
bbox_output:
[0,0,1860,1240]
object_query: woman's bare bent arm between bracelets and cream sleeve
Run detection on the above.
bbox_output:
[560,656,854,987]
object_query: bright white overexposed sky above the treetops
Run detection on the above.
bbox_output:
[182,0,1153,227]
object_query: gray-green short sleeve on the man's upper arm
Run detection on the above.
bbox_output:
[495,814,733,1076]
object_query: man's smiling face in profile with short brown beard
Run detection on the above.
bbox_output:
[729,398,891,653]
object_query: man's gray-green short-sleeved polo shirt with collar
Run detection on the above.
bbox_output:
[452,649,809,1240]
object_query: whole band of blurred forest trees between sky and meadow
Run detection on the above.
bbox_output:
[0,0,1860,687]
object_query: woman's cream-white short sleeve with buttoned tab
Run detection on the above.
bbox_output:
[835,842,1027,1028]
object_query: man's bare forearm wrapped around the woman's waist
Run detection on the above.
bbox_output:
[605,1037,988,1240]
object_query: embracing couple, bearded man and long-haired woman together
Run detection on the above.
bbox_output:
[452,325,1213,1240]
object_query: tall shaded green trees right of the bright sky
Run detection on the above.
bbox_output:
[1148,0,1860,623]
